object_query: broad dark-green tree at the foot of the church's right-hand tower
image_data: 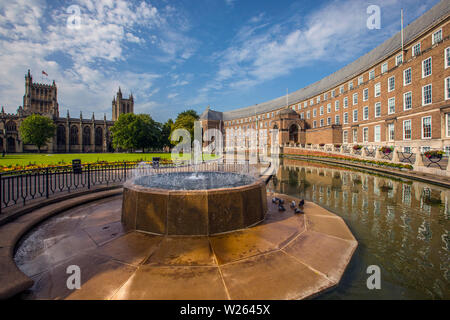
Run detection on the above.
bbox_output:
[111,113,161,151]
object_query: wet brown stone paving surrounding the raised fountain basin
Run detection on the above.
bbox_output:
[15,194,357,300]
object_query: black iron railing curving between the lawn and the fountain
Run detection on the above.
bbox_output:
[0,161,250,214]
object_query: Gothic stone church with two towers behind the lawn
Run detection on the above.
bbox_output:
[0,70,134,153]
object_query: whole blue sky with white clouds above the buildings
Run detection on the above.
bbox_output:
[0,0,438,121]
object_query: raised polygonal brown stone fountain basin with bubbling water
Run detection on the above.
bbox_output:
[122,172,267,235]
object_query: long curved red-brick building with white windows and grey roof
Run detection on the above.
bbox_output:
[201,0,450,152]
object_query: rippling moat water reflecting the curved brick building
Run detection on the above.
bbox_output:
[268,159,450,299]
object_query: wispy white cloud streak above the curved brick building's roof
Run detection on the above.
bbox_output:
[199,0,418,94]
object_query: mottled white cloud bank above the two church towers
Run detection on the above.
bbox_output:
[0,0,195,116]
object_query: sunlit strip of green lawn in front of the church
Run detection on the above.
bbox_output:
[0,153,200,167]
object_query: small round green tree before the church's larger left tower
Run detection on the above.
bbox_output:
[19,114,56,153]
